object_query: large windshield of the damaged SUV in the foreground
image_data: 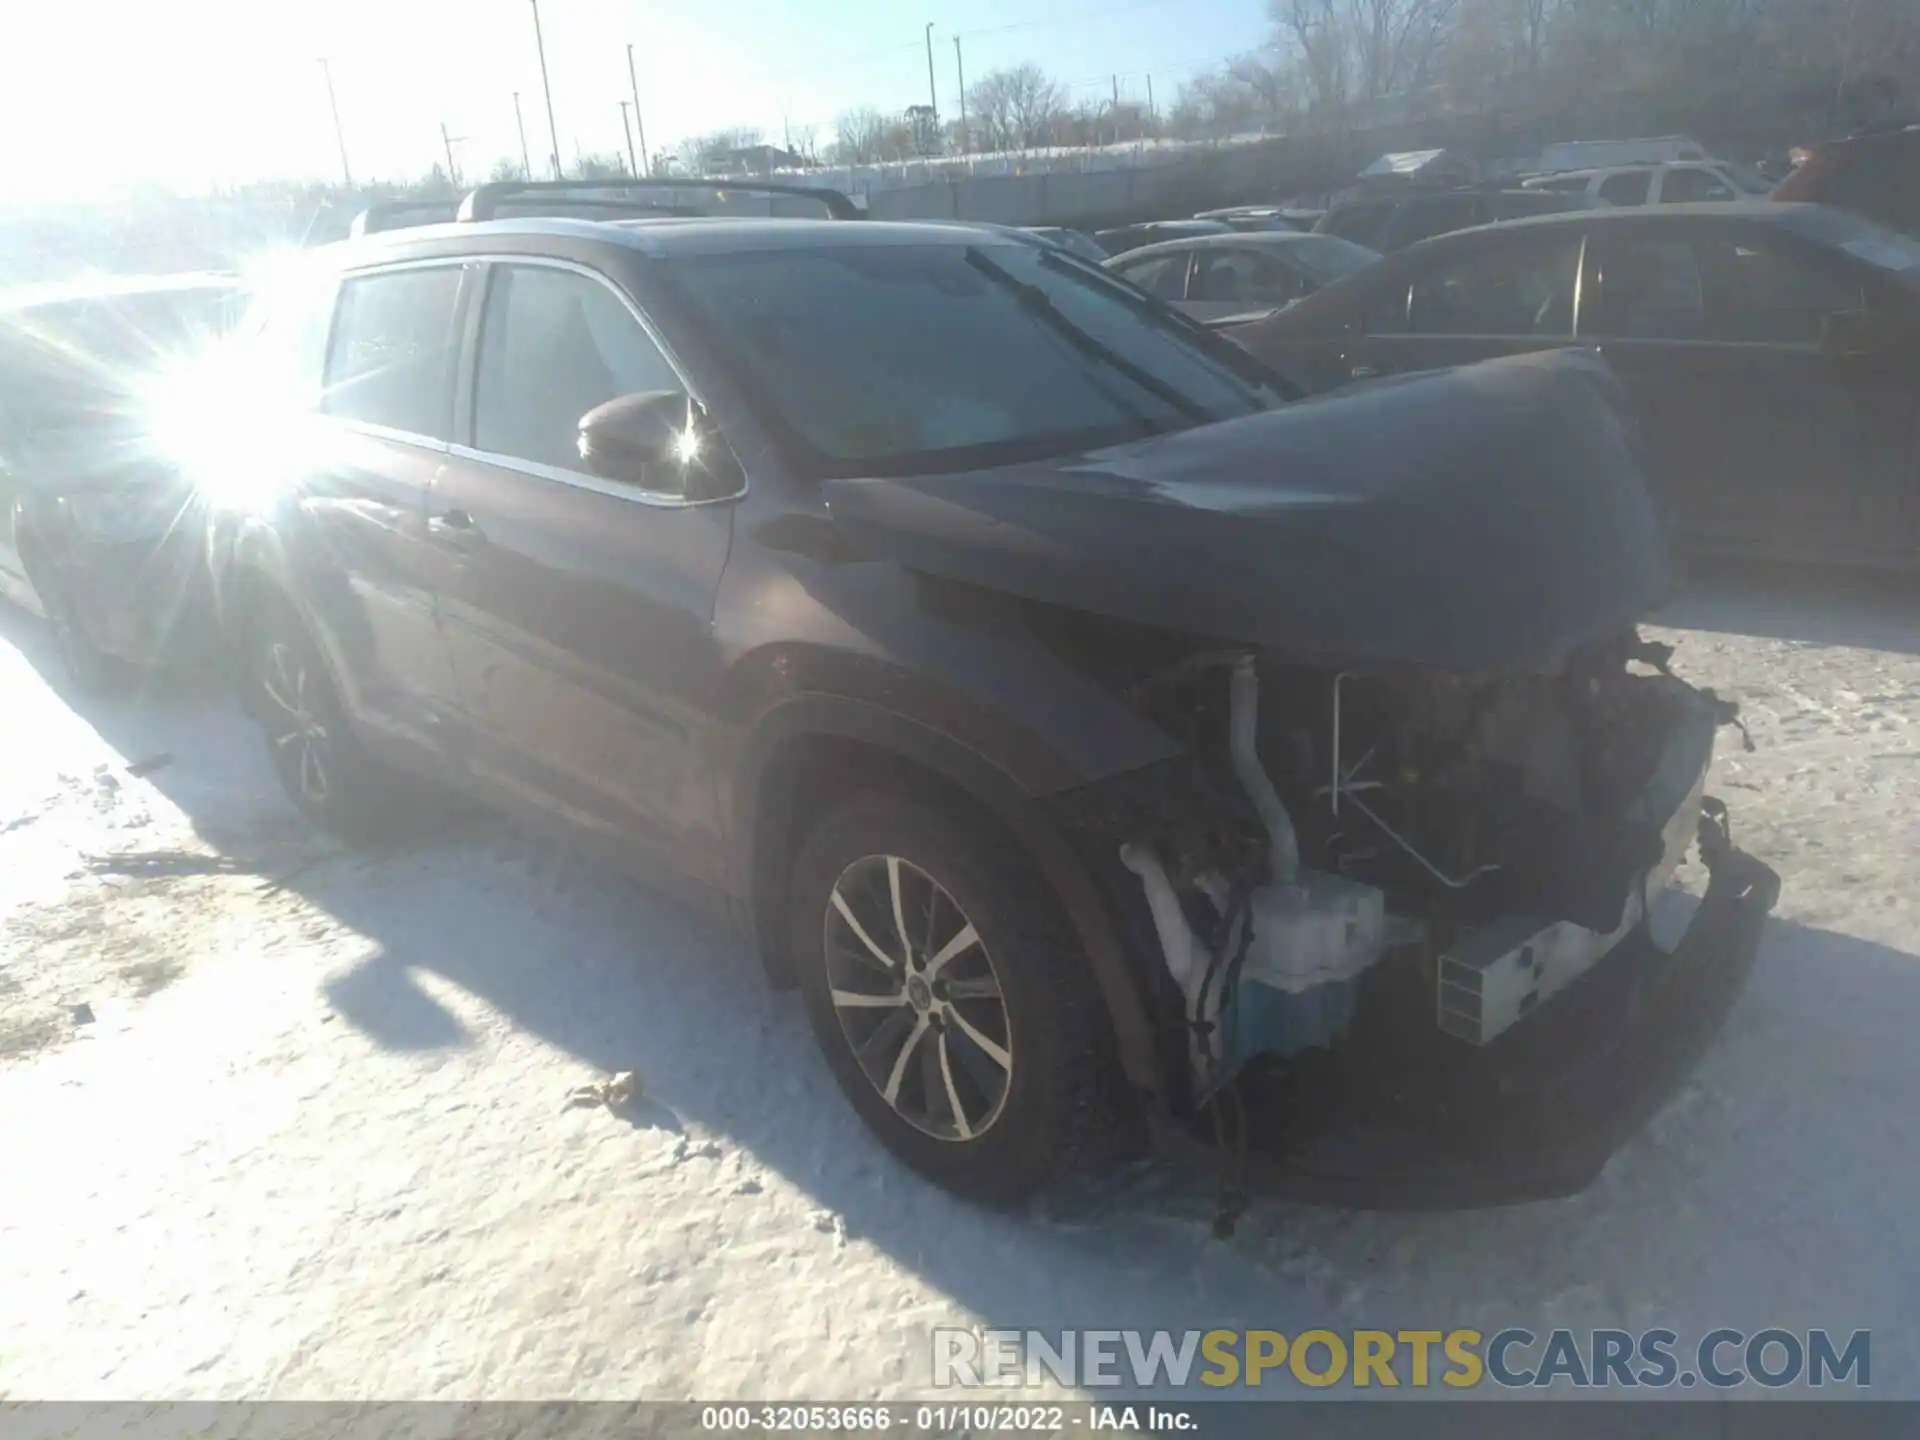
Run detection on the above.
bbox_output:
[666,244,1279,478]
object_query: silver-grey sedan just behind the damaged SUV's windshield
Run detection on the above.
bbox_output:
[1106,230,1379,321]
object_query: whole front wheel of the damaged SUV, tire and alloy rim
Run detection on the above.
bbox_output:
[789,795,1112,1204]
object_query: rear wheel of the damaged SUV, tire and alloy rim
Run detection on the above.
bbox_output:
[246,597,394,845]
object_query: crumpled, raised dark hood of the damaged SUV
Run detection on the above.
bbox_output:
[824,349,1668,672]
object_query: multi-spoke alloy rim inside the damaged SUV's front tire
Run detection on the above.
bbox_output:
[826,854,1014,1140]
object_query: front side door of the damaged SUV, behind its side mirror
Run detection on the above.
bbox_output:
[430,261,732,877]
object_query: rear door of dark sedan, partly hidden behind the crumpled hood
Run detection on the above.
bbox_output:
[1342,227,1584,380]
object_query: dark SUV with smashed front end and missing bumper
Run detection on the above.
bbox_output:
[198,184,1778,1206]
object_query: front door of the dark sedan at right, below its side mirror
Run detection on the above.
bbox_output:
[1586,221,1914,564]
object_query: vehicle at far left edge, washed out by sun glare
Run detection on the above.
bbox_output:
[0,275,240,685]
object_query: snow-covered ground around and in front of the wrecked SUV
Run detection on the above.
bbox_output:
[0,578,1920,1400]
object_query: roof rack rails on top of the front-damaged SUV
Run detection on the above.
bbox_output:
[348,177,866,238]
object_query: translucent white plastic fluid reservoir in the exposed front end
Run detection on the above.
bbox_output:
[1227,870,1386,1066]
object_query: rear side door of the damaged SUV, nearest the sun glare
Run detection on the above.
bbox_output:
[311,261,467,753]
